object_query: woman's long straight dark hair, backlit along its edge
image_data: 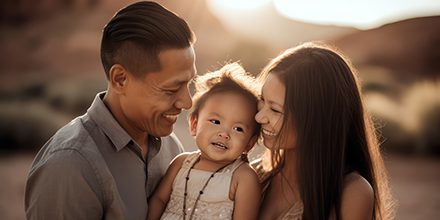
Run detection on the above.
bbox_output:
[257,42,394,220]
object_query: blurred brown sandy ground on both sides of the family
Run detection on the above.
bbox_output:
[0,154,440,220]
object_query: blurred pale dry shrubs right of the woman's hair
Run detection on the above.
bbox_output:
[366,80,440,155]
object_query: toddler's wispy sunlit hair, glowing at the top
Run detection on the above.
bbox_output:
[187,63,260,162]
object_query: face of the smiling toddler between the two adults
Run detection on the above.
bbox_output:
[190,92,257,164]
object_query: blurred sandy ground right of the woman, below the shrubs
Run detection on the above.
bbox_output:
[387,156,440,220]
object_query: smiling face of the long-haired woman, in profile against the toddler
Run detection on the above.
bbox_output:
[255,73,297,149]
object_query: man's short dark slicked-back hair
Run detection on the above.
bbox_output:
[101,1,195,79]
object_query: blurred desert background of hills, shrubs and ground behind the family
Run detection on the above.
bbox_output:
[0,0,440,220]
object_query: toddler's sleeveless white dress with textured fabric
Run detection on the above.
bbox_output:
[161,151,244,220]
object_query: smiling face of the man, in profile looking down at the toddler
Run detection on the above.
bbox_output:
[121,46,196,137]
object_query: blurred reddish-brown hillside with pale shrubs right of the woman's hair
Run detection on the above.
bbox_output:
[335,16,440,155]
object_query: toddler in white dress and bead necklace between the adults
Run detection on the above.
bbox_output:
[147,63,261,220]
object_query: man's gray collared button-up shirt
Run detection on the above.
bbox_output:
[25,93,183,220]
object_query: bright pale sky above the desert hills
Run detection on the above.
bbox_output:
[207,0,440,30]
